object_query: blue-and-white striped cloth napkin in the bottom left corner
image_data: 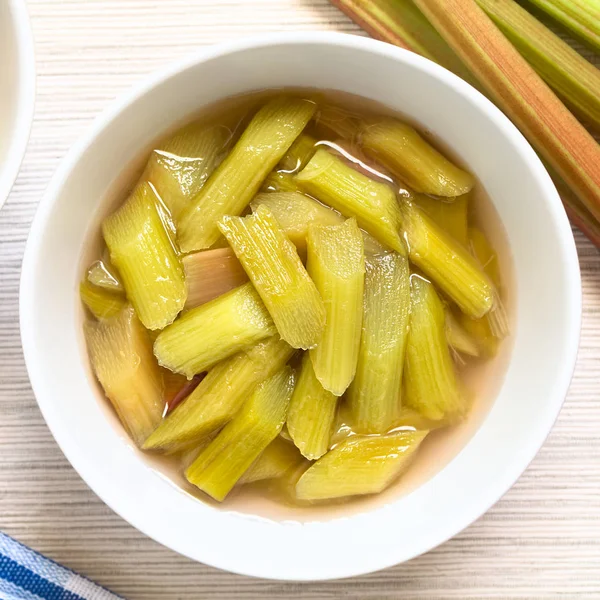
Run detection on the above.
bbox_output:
[0,532,122,600]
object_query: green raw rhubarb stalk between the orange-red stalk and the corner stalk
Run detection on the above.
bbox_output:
[477,0,600,129]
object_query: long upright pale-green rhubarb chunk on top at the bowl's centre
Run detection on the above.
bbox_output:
[306,219,365,396]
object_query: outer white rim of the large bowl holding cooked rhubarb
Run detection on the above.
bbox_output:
[20,32,582,581]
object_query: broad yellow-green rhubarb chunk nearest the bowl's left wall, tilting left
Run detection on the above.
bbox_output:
[102,183,187,329]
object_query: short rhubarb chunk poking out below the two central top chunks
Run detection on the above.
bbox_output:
[287,353,338,460]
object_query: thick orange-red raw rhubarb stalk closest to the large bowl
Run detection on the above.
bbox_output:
[415,0,600,225]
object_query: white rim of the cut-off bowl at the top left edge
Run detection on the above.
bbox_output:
[0,0,36,208]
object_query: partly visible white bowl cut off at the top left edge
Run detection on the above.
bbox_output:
[0,0,35,207]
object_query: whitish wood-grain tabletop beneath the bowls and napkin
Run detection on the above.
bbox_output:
[0,0,600,600]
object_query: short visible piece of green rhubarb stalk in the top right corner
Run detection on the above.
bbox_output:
[529,0,600,51]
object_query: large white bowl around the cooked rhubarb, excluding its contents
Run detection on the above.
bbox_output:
[21,33,581,580]
